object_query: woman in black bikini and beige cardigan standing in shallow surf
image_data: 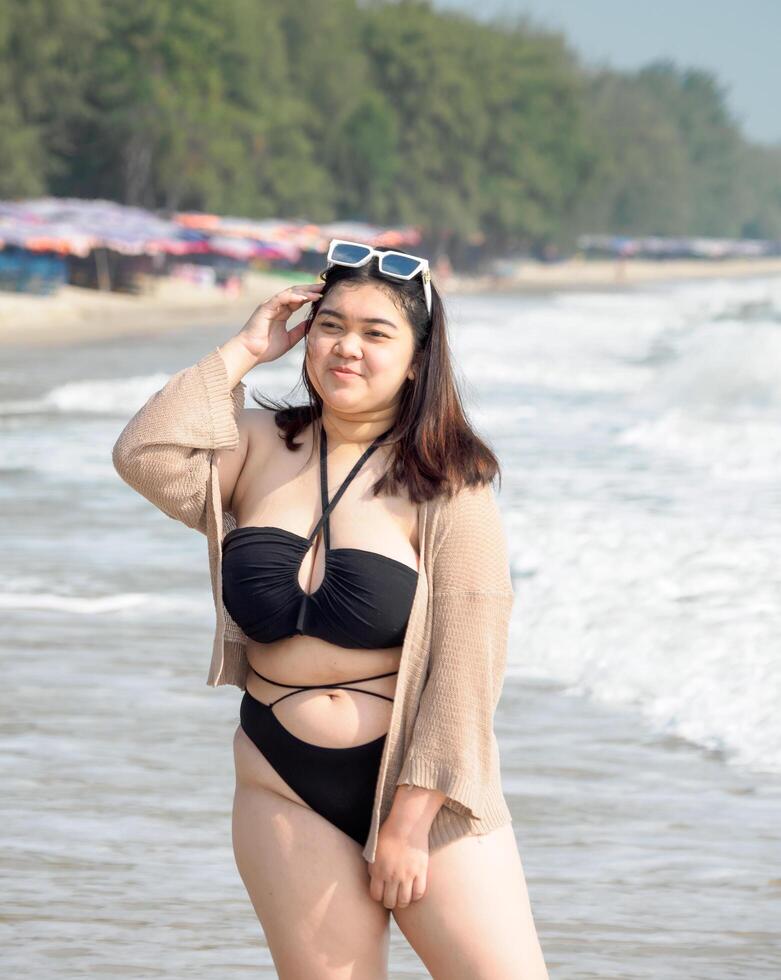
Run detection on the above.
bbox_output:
[113,240,547,980]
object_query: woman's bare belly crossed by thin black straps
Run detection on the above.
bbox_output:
[247,636,402,748]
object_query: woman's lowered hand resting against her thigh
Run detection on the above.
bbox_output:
[368,818,428,909]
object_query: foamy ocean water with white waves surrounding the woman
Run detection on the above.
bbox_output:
[0,278,781,980]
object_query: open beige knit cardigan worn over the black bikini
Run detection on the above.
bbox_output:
[112,347,514,861]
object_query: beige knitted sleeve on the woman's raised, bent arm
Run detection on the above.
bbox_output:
[111,347,245,534]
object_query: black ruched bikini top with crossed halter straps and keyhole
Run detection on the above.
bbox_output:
[222,426,418,649]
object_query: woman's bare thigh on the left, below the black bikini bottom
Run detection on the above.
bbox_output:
[232,727,390,980]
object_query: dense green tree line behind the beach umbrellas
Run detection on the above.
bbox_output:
[0,0,781,263]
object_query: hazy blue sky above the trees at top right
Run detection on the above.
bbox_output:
[433,0,781,143]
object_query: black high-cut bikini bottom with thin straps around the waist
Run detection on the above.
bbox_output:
[239,667,397,847]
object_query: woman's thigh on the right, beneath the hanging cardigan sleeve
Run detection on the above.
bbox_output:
[393,824,548,980]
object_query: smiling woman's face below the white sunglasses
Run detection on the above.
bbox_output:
[306,283,415,413]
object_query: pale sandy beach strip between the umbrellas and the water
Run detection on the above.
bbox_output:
[0,257,781,347]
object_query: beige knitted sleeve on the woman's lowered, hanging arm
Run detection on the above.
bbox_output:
[396,485,514,820]
